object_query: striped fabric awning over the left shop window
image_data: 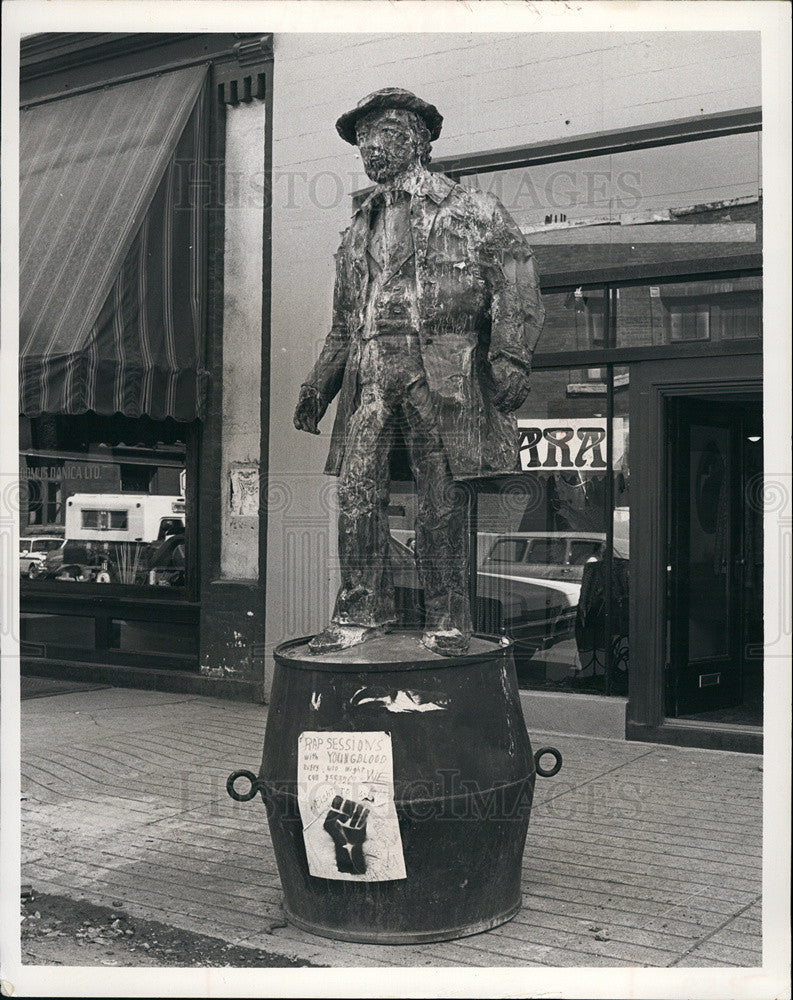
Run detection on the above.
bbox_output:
[20,66,212,421]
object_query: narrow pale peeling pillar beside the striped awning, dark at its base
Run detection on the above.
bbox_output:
[200,100,265,701]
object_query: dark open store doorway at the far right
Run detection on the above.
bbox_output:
[667,397,763,725]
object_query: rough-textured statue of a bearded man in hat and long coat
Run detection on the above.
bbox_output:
[294,88,544,656]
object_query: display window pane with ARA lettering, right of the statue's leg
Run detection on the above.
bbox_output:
[476,369,608,692]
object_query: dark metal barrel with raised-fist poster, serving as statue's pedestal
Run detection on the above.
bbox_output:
[252,632,558,944]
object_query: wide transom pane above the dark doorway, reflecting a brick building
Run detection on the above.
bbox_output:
[616,277,763,347]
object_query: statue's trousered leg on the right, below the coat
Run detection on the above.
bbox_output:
[403,379,471,655]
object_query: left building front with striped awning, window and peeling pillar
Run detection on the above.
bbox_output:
[20,33,272,700]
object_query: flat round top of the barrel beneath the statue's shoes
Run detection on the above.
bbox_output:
[273,629,512,671]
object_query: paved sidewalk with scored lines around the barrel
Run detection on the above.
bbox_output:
[22,688,762,967]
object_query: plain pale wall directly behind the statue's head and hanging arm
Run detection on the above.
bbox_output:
[266,32,761,688]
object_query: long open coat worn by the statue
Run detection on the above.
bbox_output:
[306,172,544,479]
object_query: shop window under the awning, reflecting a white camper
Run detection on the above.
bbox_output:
[20,417,188,587]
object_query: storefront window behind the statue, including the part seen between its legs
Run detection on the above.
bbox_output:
[389,367,628,694]
